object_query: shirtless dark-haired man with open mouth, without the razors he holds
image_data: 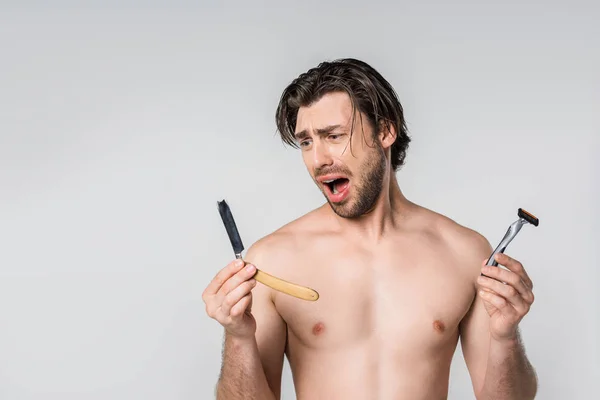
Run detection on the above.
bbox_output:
[203,59,537,400]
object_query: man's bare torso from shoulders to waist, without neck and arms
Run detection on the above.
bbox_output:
[253,207,477,400]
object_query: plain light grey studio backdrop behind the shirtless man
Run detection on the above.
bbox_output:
[0,1,600,400]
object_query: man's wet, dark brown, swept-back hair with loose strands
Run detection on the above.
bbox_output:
[275,58,410,170]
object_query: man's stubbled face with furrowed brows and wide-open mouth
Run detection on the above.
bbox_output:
[295,92,387,218]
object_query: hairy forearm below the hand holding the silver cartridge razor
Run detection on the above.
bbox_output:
[477,336,537,400]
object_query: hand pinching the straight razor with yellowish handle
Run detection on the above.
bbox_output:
[202,260,256,338]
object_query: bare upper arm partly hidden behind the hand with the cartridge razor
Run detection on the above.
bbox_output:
[460,234,492,394]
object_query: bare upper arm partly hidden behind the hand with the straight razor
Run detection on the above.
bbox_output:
[244,241,287,399]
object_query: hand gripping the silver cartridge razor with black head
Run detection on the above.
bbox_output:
[477,253,534,341]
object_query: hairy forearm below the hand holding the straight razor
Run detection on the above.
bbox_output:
[217,335,276,400]
